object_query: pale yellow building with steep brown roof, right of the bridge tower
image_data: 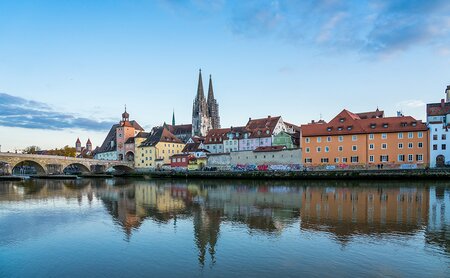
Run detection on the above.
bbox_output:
[134,127,184,168]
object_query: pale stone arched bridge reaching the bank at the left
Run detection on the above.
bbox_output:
[0,153,134,175]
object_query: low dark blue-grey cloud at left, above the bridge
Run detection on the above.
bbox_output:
[0,93,114,131]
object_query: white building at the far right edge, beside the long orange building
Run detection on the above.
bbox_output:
[427,86,450,168]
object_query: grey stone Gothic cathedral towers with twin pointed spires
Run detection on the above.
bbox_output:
[192,70,220,136]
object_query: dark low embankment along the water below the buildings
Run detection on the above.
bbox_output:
[134,169,450,180]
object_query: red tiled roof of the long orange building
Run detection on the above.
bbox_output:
[301,109,428,137]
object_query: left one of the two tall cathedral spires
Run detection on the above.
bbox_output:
[192,69,211,136]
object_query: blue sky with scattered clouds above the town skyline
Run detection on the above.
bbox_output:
[0,0,450,151]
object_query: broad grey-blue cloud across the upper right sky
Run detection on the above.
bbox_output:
[162,0,450,55]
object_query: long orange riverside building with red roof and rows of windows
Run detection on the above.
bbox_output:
[301,109,429,169]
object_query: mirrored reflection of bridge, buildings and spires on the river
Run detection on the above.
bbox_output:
[0,179,450,265]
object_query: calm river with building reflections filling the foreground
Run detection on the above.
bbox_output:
[0,179,450,277]
